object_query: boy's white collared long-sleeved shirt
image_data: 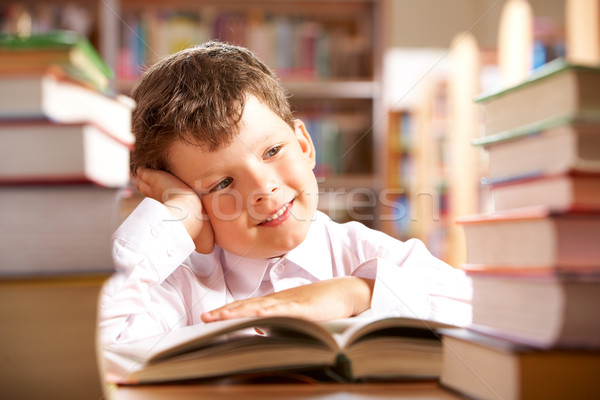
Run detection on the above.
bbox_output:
[100,199,471,346]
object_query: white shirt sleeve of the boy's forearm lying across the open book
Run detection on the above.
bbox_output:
[352,232,471,326]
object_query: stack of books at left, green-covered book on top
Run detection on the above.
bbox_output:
[0,32,134,399]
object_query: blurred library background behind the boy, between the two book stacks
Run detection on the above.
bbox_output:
[0,0,565,266]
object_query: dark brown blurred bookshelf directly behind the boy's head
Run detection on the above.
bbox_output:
[0,0,381,226]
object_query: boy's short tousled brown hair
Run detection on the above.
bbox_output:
[130,42,293,175]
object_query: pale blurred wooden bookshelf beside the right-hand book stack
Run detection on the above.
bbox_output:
[384,35,483,267]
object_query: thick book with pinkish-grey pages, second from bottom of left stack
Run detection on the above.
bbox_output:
[0,184,123,277]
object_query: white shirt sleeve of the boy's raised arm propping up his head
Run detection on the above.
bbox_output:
[99,198,195,346]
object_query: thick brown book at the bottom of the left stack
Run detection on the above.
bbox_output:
[0,276,111,400]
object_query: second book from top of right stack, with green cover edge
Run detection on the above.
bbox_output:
[474,115,600,184]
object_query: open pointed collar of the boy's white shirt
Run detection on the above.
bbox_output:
[221,211,333,300]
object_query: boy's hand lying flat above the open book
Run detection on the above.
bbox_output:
[201,276,374,322]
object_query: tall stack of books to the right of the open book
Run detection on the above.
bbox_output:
[441,59,600,400]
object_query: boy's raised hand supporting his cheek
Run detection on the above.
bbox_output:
[135,168,215,254]
